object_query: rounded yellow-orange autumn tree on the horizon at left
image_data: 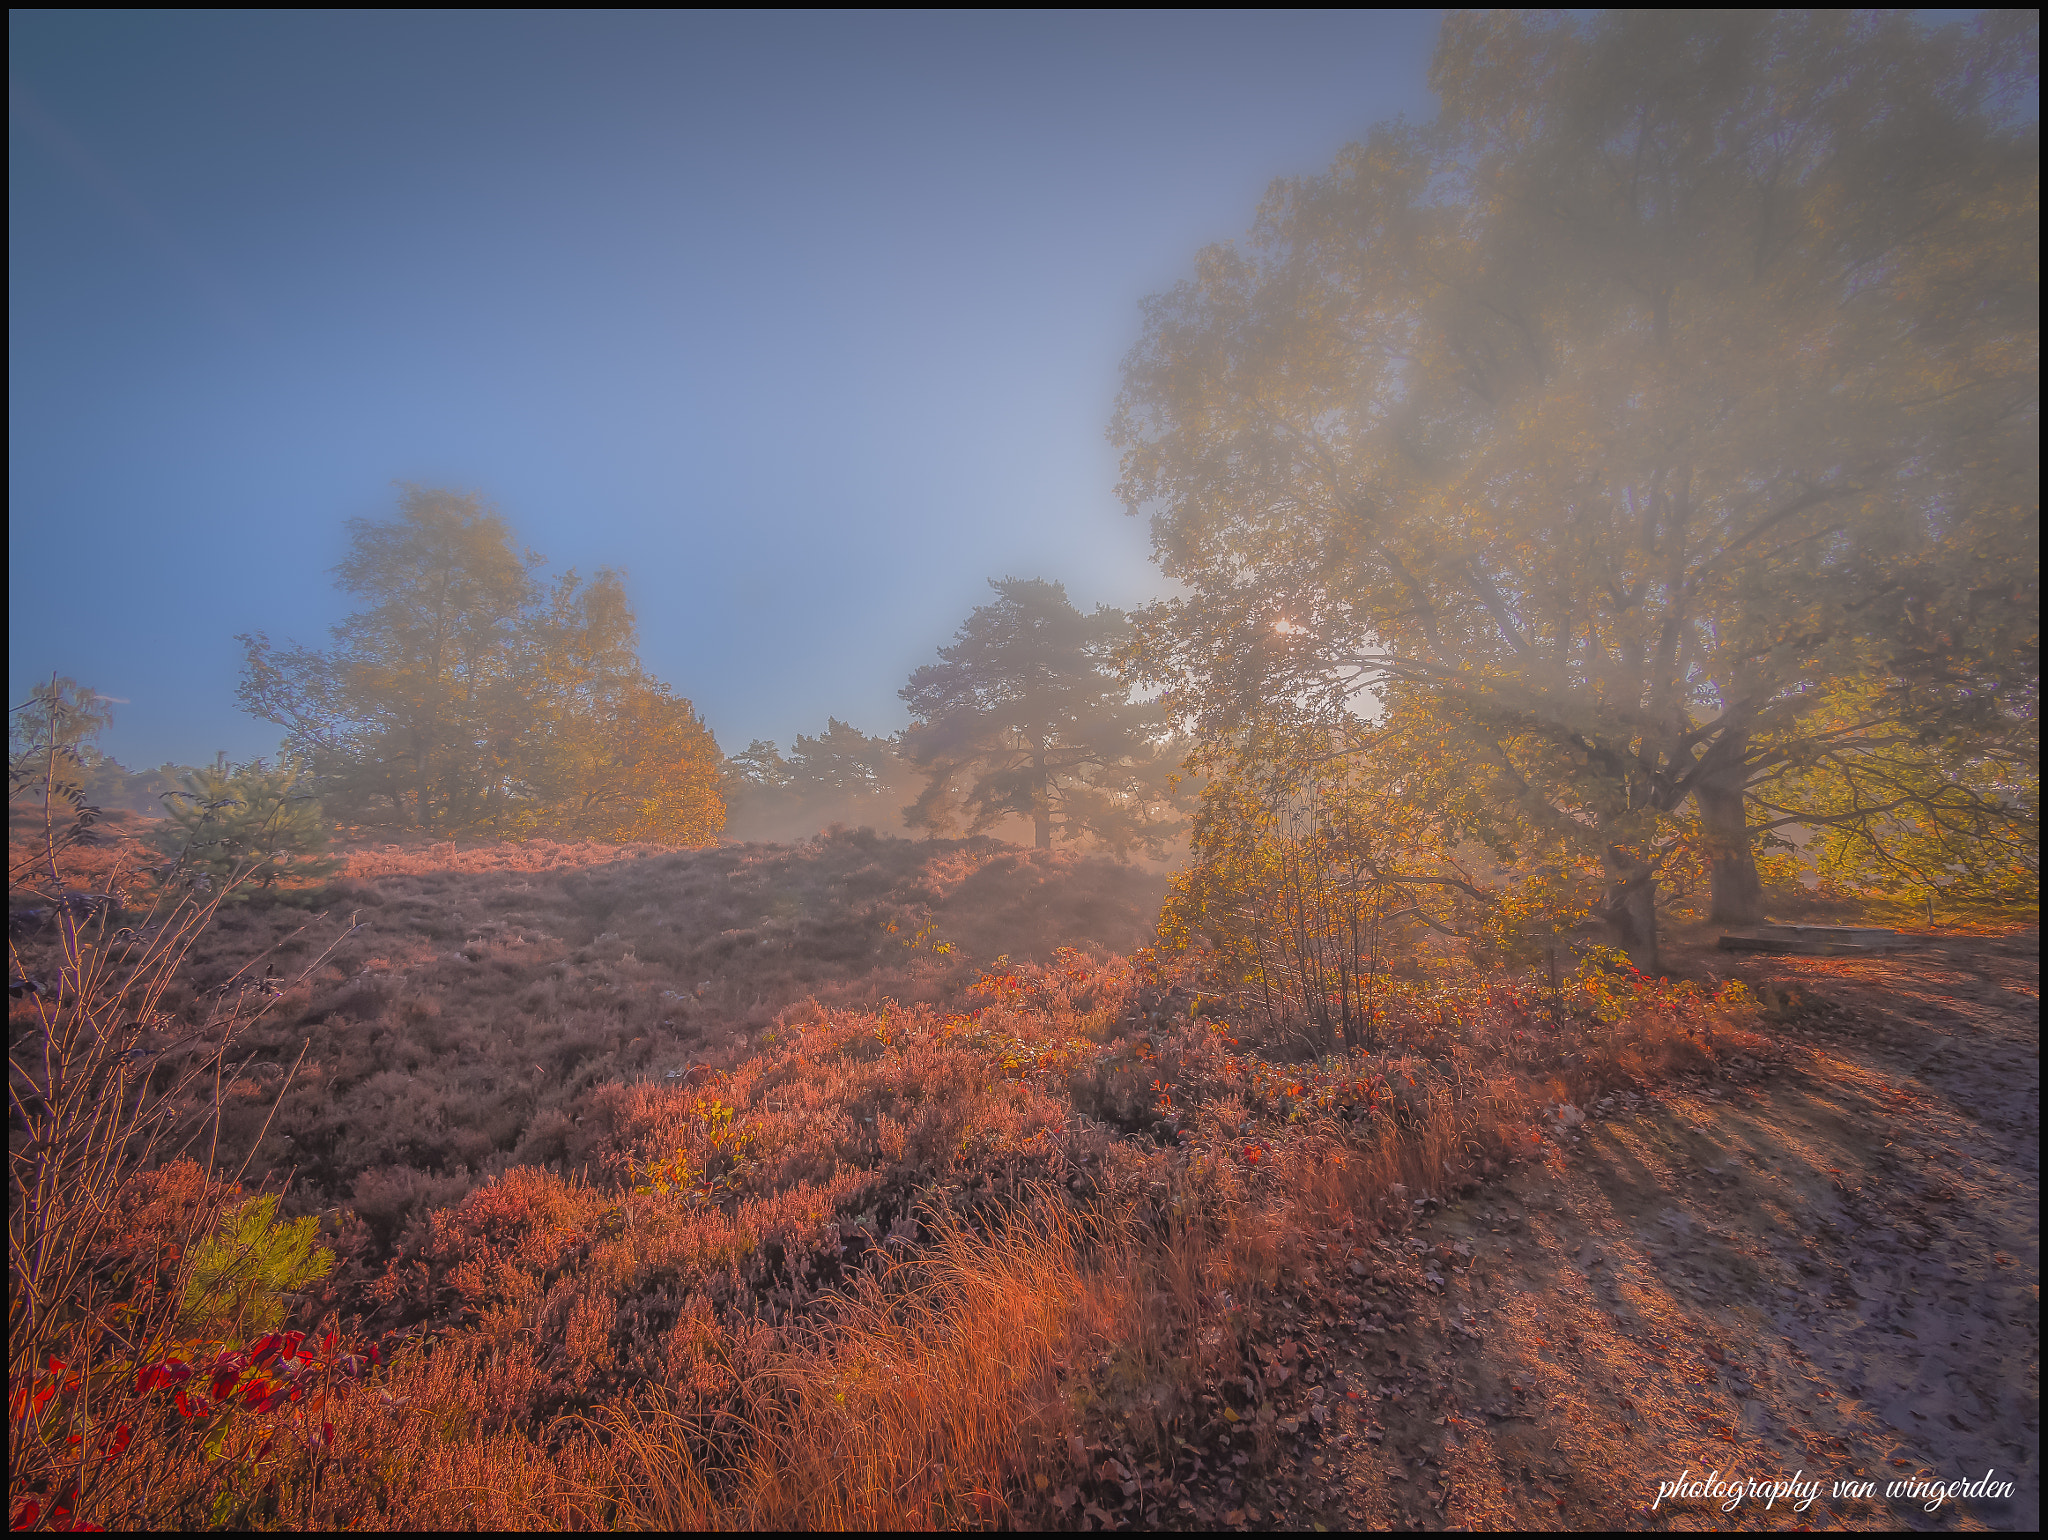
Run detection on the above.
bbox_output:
[240,487,723,844]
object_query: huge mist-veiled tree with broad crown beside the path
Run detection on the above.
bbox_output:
[1112,12,2038,958]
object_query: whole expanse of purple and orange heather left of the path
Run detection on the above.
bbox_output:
[12,806,1810,1528]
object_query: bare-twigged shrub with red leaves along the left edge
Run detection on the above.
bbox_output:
[8,696,366,1530]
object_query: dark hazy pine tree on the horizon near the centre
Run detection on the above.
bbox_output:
[899,578,1178,854]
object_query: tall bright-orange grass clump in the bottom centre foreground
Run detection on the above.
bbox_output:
[604,1206,1128,1530]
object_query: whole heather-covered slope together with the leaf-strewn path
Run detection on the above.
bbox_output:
[12,829,2040,1530]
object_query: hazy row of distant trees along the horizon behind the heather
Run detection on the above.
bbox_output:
[209,499,1186,856]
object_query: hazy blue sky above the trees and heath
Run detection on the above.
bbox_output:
[8,10,1438,764]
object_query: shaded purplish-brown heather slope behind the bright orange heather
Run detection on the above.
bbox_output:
[12,819,1165,1235]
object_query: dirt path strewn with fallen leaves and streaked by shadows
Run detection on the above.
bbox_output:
[1227,934,2040,1530]
